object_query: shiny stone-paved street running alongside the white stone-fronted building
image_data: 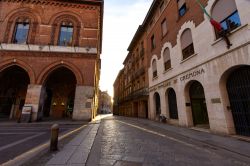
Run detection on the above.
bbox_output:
[87,115,250,166]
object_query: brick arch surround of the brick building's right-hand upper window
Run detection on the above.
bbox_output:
[49,12,81,46]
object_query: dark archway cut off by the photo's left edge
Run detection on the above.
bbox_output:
[0,65,30,119]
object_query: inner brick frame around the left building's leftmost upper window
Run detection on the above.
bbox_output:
[3,12,38,44]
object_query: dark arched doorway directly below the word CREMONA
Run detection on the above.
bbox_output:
[189,81,209,127]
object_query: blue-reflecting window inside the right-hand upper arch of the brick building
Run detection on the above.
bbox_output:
[58,23,74,46]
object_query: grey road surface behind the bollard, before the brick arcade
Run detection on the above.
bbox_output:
[0,121,82,165]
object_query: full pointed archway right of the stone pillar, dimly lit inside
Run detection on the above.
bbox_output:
[42,67,77,119]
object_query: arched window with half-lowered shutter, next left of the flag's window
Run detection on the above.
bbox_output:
[181,29,194,60]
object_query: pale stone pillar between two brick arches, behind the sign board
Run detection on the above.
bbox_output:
[25,84,42,122]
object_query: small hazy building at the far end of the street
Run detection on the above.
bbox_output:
[98,91,112,114]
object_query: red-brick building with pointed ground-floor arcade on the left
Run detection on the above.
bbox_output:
[0,0,103,121]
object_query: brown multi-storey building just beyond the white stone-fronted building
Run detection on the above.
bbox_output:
[114,26,149,118]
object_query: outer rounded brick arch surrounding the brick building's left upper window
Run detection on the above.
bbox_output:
[4,8,41,44]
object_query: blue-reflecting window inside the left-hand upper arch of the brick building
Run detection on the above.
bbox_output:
[13,20,30,44]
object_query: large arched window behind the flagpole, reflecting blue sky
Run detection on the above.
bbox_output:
[212,0,241,37]
